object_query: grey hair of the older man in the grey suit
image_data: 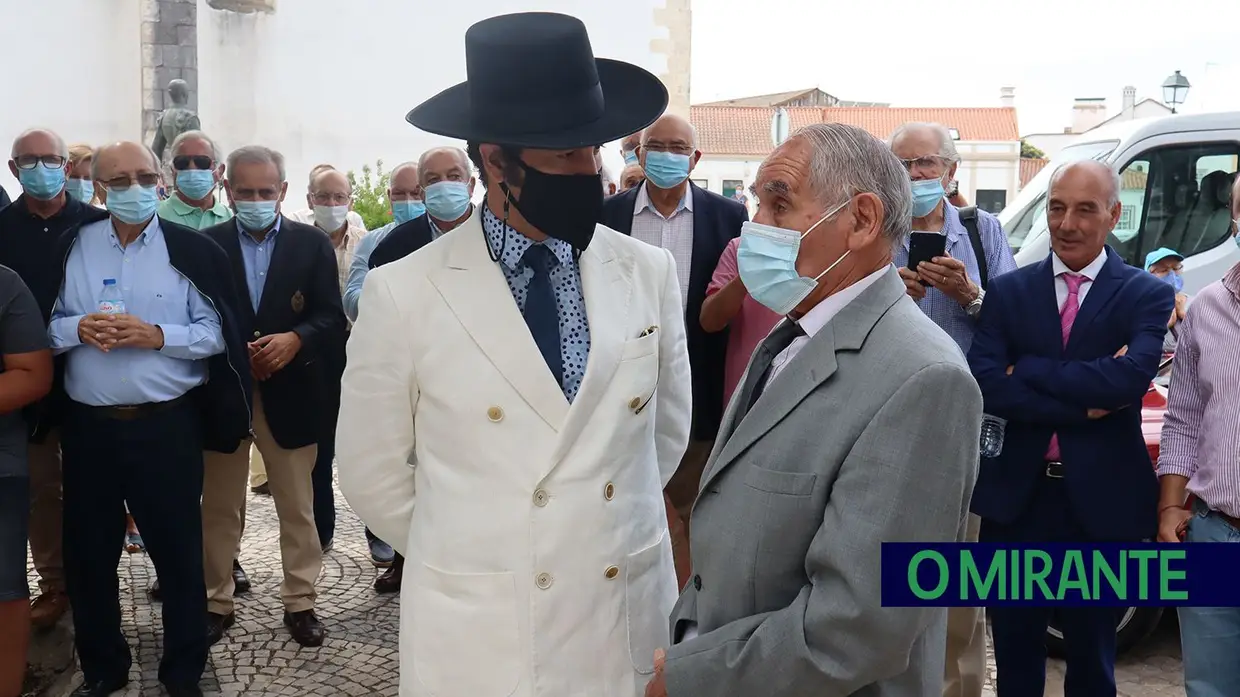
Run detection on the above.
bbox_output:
[789,123,913,243]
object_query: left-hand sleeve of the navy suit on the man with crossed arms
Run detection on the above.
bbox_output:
[968,277,1086,425]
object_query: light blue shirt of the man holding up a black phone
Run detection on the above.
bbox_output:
[893,202,1016,355]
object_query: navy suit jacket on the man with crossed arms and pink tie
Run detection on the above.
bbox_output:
[968,247,1176,541]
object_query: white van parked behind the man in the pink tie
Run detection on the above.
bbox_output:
[999,112,1240,295]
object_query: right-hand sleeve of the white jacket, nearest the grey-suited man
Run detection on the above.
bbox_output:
[655,249,693,486]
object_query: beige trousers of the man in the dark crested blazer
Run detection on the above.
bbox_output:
[202,389,322,615]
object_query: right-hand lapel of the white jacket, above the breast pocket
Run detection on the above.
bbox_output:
[548,228,636,476]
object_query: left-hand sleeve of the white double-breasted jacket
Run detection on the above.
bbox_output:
[336,265,419,553]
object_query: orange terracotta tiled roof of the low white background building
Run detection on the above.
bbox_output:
[691,105,1021,156]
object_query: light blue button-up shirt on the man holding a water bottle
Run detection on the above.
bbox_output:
[48,217,224,407]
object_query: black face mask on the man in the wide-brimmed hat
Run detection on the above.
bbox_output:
[500,160,603,252]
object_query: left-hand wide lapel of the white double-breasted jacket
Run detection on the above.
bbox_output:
[429,216,567,432]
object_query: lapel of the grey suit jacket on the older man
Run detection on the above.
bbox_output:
[702,267,905,489]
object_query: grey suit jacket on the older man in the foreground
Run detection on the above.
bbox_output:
[665,267,982,697]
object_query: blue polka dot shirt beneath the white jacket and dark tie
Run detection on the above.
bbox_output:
[482,207,590,402]
